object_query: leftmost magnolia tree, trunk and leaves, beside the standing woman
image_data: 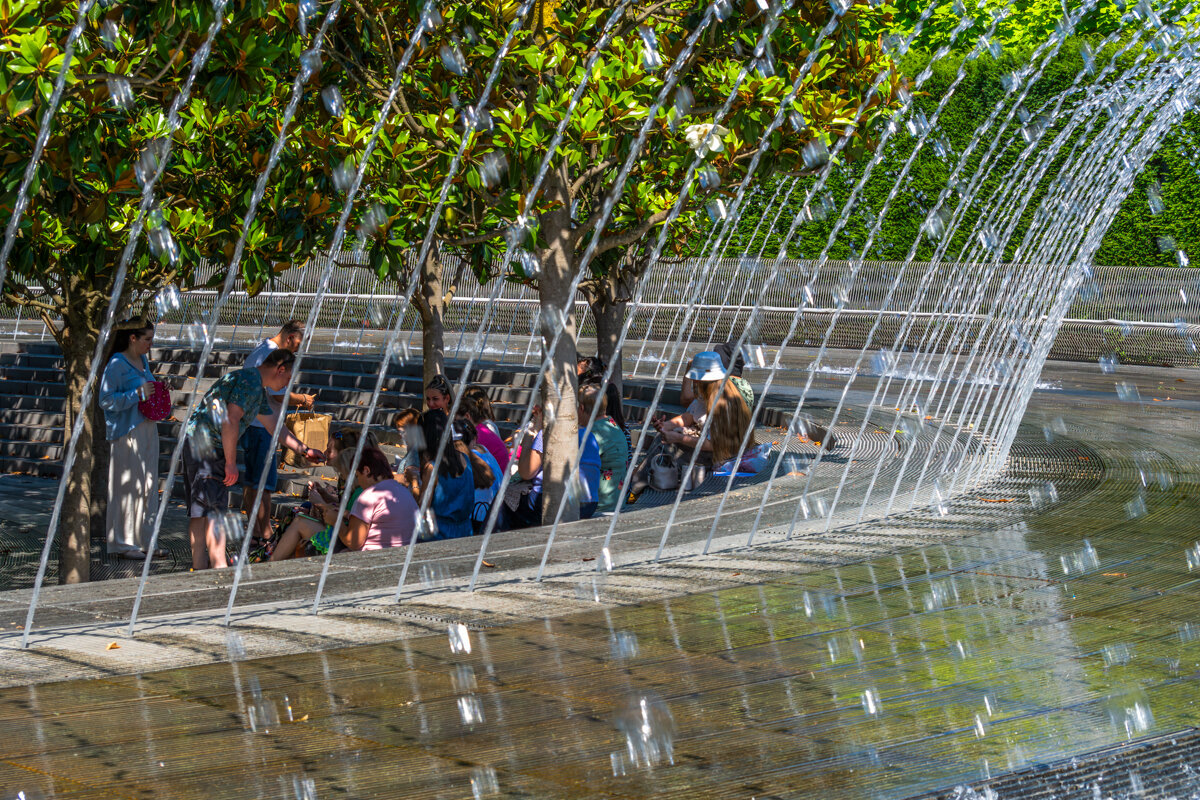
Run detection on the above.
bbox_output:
[0,0,427,582]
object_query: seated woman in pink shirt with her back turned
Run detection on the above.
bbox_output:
[341,447,418,551]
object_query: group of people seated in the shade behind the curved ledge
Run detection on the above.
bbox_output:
[269,345,755,561]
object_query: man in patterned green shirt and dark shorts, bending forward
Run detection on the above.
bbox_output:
[184,349,324,570]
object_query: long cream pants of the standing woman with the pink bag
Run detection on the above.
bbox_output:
[107,420,158,555]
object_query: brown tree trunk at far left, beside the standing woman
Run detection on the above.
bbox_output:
[58,314,98,583]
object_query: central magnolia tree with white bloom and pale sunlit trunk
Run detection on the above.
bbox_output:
[342,0,902,518]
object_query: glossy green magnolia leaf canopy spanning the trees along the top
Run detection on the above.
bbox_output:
[0,0,899,309]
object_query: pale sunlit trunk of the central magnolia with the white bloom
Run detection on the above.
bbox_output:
[538,164,582,525]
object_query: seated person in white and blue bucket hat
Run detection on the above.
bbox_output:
[626,350,756,504]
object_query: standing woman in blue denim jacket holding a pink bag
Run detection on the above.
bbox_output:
[100,319,166,561]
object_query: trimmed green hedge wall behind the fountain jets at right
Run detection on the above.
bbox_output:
[728,37,1200,266]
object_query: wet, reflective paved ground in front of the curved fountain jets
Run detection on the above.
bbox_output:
[0,364,1200,800]
